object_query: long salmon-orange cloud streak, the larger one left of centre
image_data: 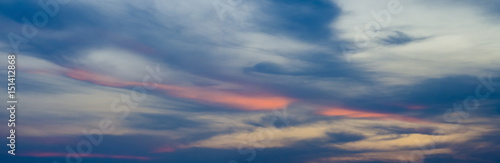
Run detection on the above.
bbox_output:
[66,70,294,110]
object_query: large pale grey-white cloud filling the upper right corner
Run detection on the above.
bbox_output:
[332,0,500,85]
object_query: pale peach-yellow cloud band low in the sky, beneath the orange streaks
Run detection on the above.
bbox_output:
[188,116,492,162]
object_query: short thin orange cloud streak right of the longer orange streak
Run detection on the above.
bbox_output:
[317,108,428,123]
